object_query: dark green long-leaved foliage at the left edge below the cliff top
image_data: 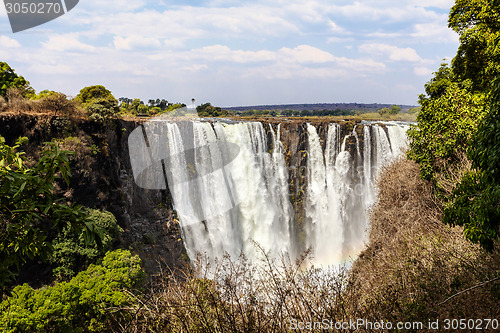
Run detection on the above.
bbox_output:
[0,136,100,288]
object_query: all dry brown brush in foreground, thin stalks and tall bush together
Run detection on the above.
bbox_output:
[115,160,500,332]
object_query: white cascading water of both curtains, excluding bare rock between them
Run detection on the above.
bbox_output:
[158,121,408,265]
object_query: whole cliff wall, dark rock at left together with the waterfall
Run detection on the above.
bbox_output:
[0,116,408,273]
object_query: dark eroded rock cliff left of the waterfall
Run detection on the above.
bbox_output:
[0,115,187,275]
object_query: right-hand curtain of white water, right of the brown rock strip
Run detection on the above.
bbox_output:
[305,124,408,265]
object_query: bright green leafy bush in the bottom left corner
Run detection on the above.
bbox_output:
[0,250,145,332]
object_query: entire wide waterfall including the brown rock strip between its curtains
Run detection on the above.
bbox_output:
[128,118,409,265]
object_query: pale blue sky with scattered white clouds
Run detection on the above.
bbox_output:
[0,0,458,106]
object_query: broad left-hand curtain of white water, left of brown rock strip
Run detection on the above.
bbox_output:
[166,122,292,259]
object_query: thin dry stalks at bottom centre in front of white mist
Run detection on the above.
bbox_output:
[123,249,356,332]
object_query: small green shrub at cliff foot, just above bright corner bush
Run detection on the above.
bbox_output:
[49,209,123,279]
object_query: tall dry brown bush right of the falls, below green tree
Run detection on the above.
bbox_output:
[351,160,500,321]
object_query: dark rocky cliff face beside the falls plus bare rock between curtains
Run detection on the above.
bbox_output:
[0,115,368,274]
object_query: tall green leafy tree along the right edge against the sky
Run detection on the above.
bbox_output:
[408,0,500,250]
